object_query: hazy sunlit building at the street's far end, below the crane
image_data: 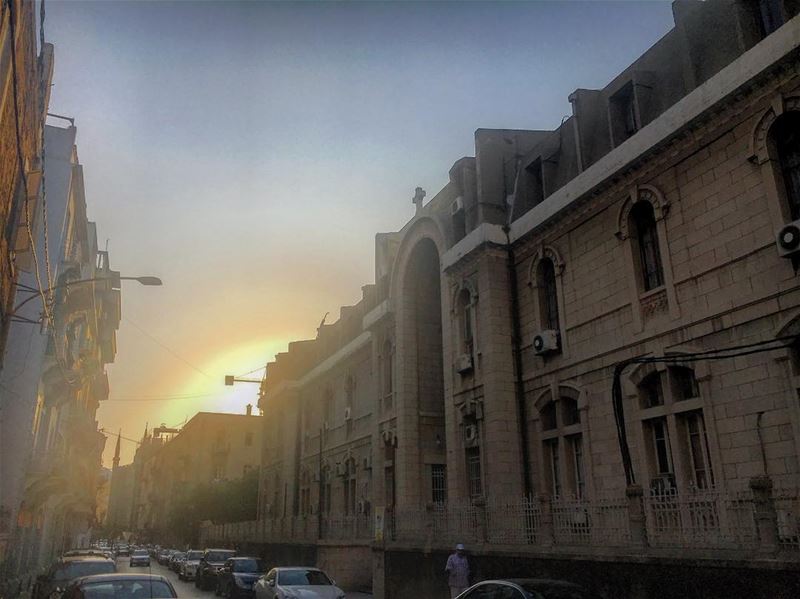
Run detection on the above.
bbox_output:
[125,407,263,543]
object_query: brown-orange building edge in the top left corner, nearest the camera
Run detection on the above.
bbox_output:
[0,0,53,366]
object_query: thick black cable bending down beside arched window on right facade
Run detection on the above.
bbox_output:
[611,336,798,485]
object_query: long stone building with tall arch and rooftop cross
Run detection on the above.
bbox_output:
[204,0,800,597]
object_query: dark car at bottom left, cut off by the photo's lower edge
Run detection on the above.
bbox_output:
[62,574,178,599]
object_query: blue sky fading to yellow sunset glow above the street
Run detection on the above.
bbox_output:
[44,0,673,466]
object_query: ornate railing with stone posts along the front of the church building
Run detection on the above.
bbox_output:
[203,478,800,560]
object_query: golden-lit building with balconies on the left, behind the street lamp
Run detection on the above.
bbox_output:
[0,123,121,572]
